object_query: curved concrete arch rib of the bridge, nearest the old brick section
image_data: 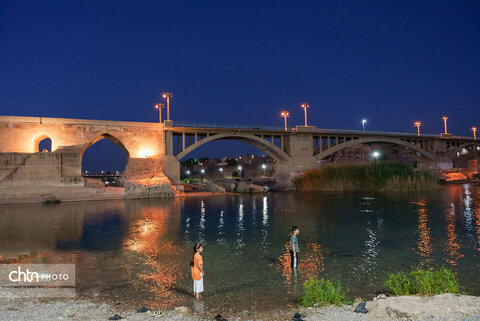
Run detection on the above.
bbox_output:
[175,132,290,161]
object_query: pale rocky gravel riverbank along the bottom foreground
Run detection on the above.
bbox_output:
[0,294,480,321]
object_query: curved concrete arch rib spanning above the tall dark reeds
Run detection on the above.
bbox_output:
[315,137,435,161]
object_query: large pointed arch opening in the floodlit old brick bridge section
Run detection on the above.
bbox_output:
[81,134,129,187]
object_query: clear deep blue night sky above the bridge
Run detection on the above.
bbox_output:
[0,0,480,170]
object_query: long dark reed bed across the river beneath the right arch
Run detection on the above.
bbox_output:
[294,162,438,192]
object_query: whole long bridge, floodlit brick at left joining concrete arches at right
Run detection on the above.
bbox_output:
[0,116,480,197]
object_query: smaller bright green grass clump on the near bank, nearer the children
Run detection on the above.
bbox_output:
[299,277,351,307]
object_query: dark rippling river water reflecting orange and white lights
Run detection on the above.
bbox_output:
[0,184,480,311]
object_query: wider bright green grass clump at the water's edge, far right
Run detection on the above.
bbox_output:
[385,267,460,295]
